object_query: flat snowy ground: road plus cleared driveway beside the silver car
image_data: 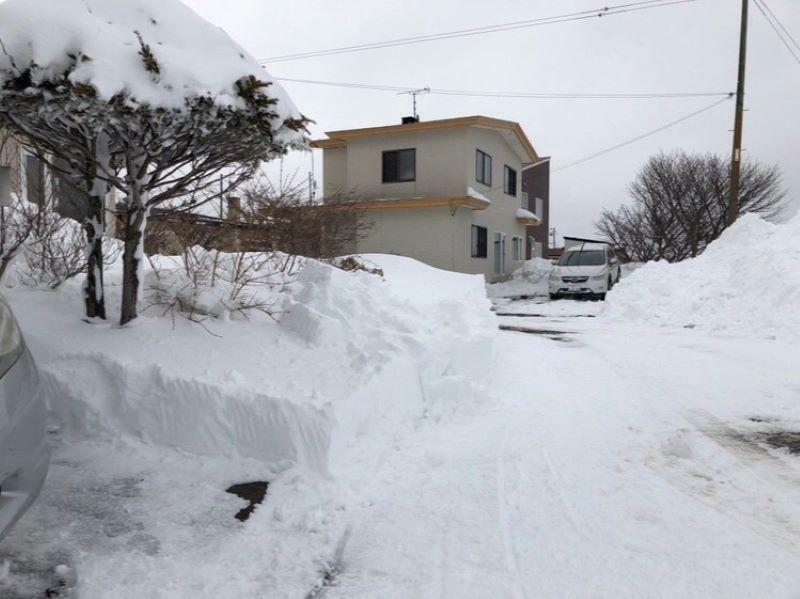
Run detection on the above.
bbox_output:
[0,301,800,599]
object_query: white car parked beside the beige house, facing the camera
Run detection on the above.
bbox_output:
[548,243,622,300]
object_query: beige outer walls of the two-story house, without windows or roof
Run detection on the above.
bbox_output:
[323,127,526,281]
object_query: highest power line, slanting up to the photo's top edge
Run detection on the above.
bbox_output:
[259,0,696,63]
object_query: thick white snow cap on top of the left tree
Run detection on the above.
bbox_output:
[0,0,299,123]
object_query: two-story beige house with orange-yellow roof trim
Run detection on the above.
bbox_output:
[312,116,541,281]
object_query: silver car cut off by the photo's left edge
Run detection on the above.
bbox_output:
[0,297,50,540]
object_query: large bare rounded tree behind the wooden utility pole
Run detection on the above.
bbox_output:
[596,152,787,262]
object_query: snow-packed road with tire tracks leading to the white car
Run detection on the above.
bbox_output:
[325,302,800,598]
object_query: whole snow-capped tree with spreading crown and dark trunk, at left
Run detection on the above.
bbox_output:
[0,0,307,324]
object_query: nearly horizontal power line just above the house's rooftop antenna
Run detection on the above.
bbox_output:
[274,77,730,100]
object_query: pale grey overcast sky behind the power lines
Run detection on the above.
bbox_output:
[185,0,800,243]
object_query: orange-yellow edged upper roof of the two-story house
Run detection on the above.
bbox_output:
[311,115,541,163]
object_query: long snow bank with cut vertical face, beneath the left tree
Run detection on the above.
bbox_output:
[8,256,496,474]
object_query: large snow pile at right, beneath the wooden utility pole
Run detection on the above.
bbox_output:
[603,215,800,340]
